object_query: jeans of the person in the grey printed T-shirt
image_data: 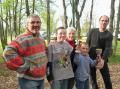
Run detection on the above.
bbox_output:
[51,79,68,89]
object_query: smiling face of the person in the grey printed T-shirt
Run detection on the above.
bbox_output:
[57,29,66,42]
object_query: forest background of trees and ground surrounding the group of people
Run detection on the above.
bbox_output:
[0,0,120,89]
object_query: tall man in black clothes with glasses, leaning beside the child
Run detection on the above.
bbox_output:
[87,15,113,89]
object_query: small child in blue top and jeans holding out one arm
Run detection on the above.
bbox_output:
[74,42,101,89]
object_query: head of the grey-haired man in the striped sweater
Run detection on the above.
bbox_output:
[26,15,41,34]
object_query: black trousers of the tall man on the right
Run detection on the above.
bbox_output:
[91,62,112,89]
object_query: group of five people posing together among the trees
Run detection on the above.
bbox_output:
[3,14,113,89]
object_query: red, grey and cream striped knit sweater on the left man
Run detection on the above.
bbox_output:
[3,32,48,79]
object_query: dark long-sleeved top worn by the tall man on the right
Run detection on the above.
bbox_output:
[87,28,113,61]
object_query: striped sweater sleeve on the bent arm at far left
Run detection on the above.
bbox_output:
[3,41,29,73]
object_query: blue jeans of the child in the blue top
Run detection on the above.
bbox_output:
[76,79,89,89]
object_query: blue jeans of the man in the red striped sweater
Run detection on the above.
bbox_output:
[18,78,44,89]
